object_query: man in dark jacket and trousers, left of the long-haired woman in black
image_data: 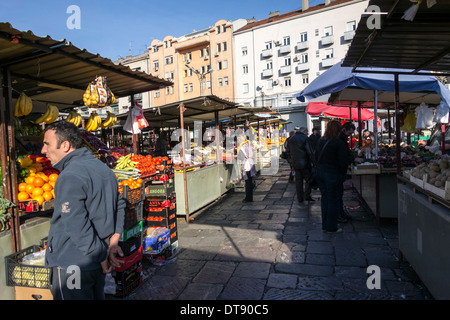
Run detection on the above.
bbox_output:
[288,127,314,203]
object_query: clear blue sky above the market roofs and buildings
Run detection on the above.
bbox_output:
[0,0,324,61]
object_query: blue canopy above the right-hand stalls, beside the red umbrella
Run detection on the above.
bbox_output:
[294,62,450,106]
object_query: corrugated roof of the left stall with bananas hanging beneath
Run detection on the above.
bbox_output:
[0,23,173,109]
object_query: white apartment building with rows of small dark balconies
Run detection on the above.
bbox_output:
[234,0,368,130]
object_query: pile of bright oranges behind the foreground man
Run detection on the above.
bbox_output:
[17,171,58,206]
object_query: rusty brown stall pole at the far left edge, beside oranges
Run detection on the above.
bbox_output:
[0,69,21,252]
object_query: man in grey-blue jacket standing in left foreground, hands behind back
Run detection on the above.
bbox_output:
[42,121,126,300]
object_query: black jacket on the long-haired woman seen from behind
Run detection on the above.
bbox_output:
[315,138,351,175]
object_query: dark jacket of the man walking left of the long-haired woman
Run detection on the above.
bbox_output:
[288,132,312,170]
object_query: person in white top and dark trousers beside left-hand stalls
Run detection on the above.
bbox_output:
[237,135,256,202]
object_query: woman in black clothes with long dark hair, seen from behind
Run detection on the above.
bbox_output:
[315,120,350,233]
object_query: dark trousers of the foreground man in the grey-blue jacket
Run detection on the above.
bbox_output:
[50,267,105,300]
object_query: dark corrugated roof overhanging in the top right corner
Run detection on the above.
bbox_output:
[342,0,450,73]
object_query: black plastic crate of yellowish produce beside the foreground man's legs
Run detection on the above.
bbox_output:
[5,246,51,289]
